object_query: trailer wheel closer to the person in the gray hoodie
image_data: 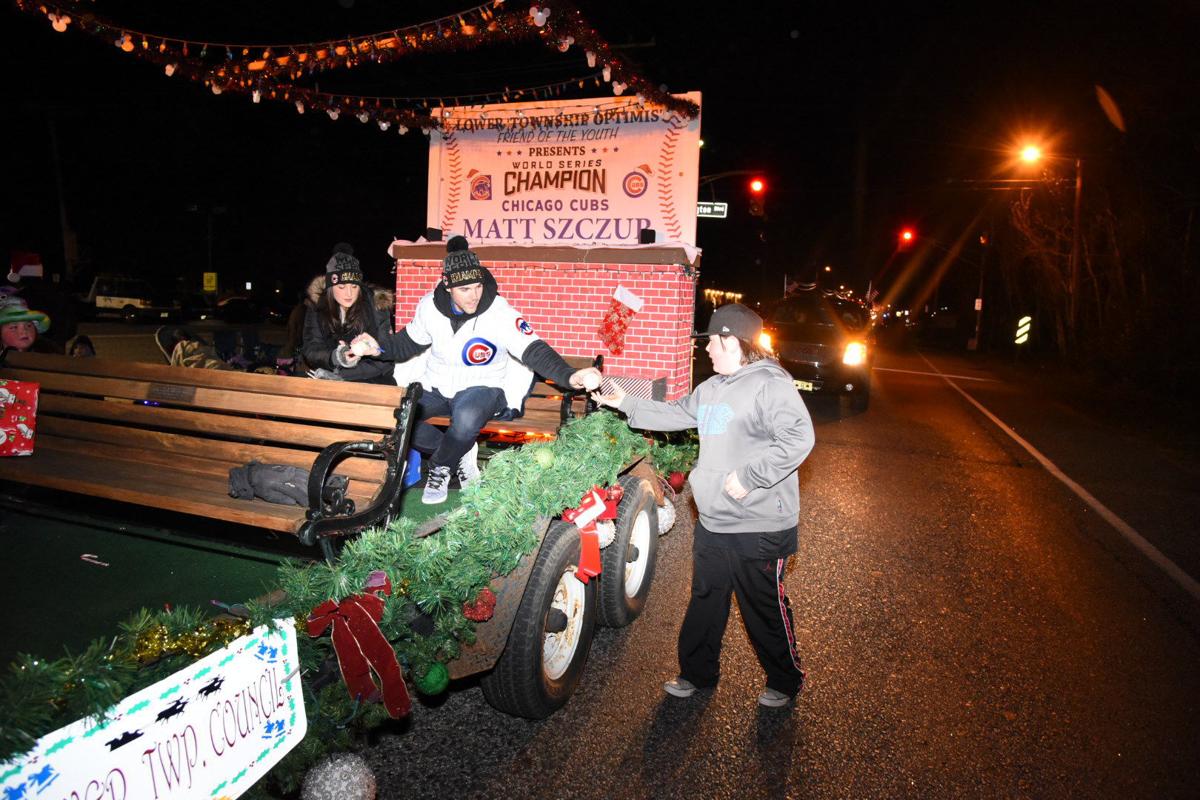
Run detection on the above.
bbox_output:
[600,475,659,627]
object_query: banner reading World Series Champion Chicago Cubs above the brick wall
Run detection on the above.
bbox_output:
[426,92,700,246]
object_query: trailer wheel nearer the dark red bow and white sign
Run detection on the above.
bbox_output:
[480,519,596,720]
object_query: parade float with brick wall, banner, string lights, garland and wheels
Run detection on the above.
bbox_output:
[0,4,700,799]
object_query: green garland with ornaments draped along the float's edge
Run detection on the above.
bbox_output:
[0,411,650,792]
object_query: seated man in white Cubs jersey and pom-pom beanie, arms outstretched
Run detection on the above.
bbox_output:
[340,236,601,504]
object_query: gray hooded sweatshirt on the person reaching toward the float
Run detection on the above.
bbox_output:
[620,359,815,534]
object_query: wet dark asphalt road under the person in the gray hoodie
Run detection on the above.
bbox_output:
[367,353,1200,799]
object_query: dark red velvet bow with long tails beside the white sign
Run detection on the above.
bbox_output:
[308,570,413,718]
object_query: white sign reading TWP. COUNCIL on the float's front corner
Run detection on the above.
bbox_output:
[0,619,307,800]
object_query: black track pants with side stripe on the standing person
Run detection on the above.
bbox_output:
[679,534,804,696]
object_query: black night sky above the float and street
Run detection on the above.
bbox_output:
[2,0,1200,303]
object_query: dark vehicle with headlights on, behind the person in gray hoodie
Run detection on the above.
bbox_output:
[763,289,875,411]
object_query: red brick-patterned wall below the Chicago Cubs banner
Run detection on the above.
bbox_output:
[396,259,696,399]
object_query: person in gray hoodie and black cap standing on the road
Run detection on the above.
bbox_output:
[592,303,815,706]
